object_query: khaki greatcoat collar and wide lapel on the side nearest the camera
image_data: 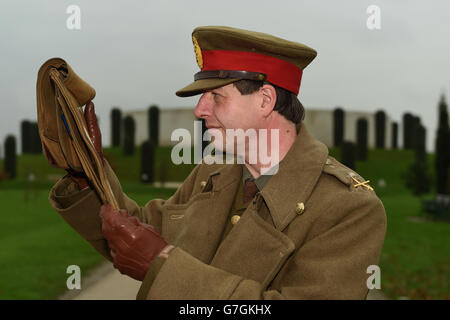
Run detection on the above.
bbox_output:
[211,126,328,288]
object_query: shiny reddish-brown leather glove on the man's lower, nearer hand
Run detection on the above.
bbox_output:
[100,204,173,281]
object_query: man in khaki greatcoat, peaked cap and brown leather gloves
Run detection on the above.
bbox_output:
[50,27,386,299]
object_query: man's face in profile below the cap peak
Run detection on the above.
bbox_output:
[194,84,263,155]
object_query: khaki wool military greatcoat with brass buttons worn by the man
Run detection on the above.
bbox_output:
[50,125,386,299]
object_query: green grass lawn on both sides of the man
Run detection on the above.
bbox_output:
[0,148,450,299]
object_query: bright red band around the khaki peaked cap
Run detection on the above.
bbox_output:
[202,50,302,95]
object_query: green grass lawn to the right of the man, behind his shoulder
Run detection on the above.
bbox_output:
[330,150,450,299]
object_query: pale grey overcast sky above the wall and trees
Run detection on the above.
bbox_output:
[0,0,450,154]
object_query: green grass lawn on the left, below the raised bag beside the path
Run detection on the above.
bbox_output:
[0,181,174,299]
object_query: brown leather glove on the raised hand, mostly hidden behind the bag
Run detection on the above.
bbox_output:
[66,101,105,189]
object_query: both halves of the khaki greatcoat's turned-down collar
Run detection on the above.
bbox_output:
[204,124,328,231]
